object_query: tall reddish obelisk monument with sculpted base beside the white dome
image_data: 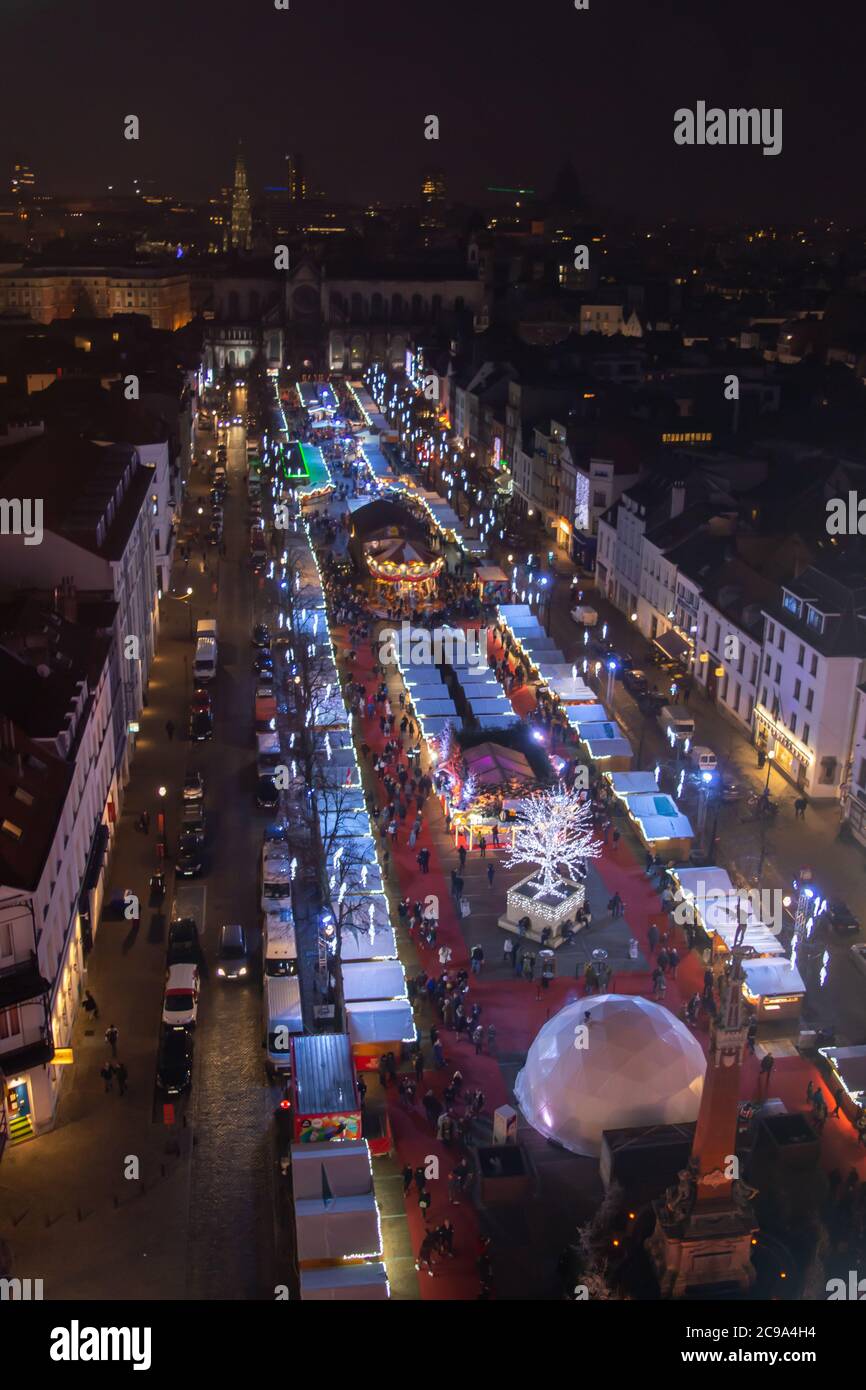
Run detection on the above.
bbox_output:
[646,927,758,1298]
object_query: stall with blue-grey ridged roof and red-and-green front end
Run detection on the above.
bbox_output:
[289,1033,361,1144]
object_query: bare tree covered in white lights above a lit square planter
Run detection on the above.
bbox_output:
[505,783,602,891]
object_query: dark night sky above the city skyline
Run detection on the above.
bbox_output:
[0,0,866,224]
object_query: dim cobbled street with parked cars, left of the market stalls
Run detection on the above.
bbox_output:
[0,389,275,1300]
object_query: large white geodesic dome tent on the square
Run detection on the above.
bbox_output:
[514,994,706,1158]
